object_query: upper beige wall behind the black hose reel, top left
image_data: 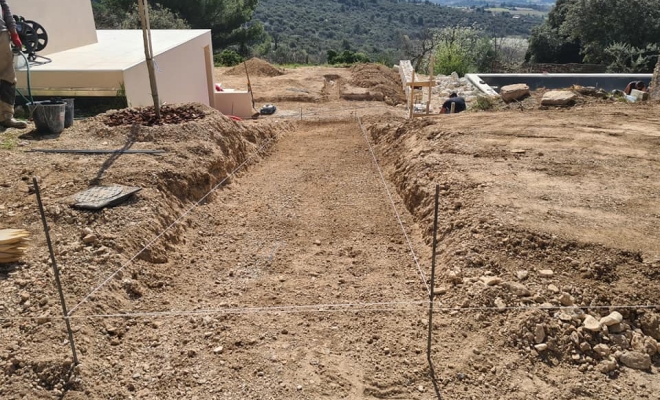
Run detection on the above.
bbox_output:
[8,0,97,56]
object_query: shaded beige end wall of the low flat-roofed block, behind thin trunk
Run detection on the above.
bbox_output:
[124,31,213,107]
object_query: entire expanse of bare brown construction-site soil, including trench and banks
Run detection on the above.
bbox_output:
[0,66,660,400]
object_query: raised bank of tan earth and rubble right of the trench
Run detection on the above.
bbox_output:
[367,107,660,399]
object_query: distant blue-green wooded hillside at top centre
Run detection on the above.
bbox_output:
[254,0,543,63]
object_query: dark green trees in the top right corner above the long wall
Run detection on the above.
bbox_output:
[527,0,660,72]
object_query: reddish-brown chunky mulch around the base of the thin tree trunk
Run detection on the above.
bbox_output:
[105,104,206,126]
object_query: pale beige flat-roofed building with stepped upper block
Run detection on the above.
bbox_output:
[10,0,216,107]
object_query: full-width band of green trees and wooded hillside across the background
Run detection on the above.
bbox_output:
[92,0,660,72]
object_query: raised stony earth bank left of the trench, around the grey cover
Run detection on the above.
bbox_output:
[0,104,288,398]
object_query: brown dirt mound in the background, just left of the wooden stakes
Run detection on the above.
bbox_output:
[350,64,406,106]
